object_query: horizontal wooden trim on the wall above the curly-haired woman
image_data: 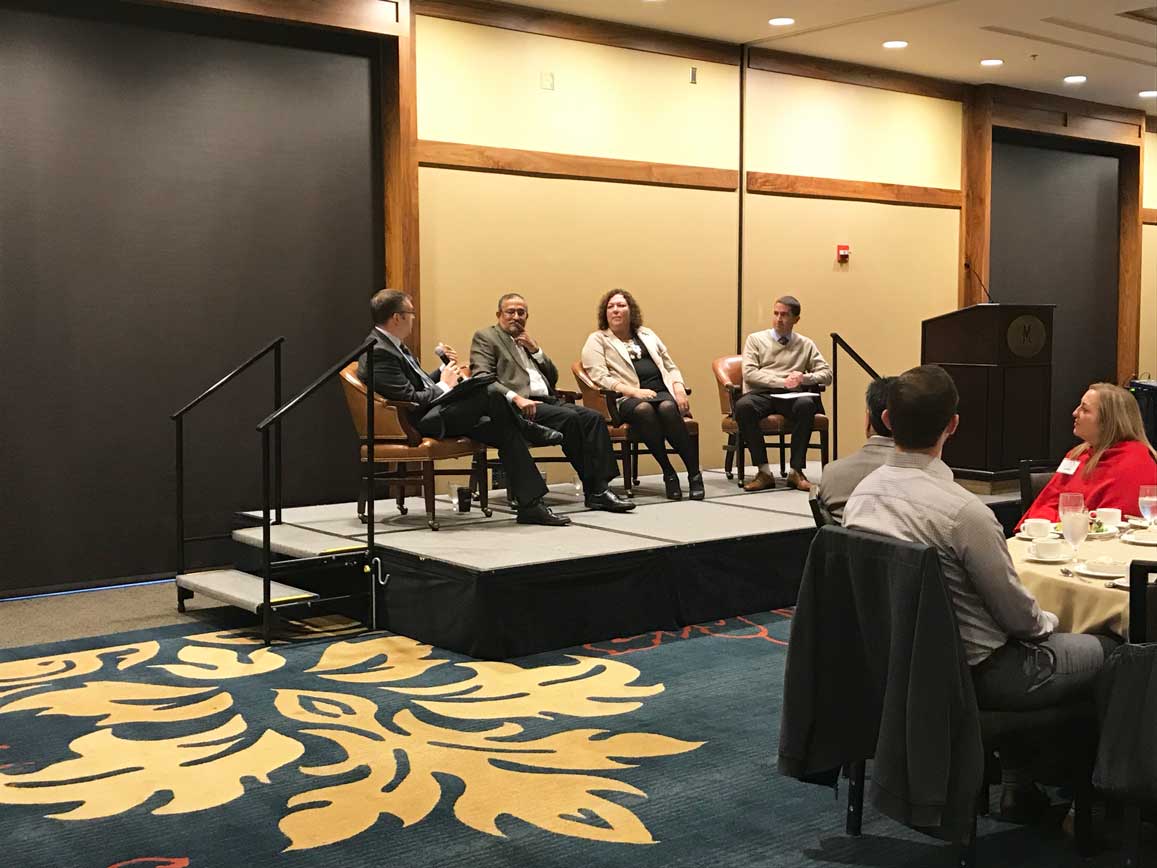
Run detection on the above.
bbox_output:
[418,139,739,192]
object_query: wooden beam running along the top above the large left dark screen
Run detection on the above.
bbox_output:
[131,0,407,36]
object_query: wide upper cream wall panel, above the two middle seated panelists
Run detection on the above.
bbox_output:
[417,16,739,169]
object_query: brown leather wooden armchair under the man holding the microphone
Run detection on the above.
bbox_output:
[339,362,491,530]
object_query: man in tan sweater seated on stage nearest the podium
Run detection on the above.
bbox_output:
[735,295,832,491]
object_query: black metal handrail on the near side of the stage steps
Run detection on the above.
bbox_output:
[257,338,377,645]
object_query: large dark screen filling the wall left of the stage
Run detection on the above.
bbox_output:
[0,2,382,596]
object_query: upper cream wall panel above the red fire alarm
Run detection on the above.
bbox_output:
[745,69,963,190]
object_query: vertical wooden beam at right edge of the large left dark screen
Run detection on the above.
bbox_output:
[381,0,421,350]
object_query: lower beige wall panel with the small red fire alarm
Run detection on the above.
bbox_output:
[742,196,960,455]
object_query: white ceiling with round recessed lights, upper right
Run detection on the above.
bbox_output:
[488,0,1157,115]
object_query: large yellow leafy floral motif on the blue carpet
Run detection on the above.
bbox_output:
[0,632,702,849]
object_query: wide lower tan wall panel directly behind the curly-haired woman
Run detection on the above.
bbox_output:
[420,169,738,479]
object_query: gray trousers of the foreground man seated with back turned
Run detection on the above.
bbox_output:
[972,633,1119,712]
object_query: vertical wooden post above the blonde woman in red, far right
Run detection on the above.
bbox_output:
[1117,148,1144,383]
